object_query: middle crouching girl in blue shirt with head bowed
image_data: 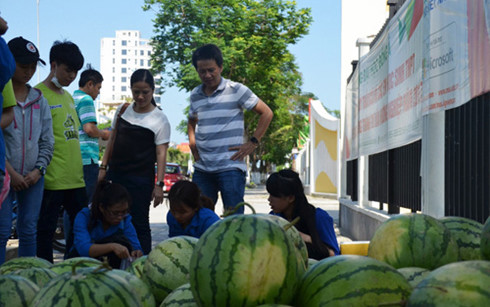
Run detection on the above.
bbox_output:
[167,180,220,238]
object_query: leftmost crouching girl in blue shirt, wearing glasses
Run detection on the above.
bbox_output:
[70,180,143,268]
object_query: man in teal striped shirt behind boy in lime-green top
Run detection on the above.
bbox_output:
[73,65,110,203]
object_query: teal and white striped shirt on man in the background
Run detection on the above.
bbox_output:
[73,90,99,165]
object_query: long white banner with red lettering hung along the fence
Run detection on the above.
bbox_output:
[352,0,490,160]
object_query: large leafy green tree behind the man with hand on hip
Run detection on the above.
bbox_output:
[144,0,312,172]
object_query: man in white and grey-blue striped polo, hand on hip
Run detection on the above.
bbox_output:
[187,44,273,213]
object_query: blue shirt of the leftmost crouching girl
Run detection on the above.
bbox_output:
[73,208,143,257]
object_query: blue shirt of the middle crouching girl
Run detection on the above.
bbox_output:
[167,208,220,238]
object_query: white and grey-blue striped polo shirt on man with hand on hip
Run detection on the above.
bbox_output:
[189,78,259,173]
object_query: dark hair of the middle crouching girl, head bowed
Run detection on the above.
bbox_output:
[168,180,214,211]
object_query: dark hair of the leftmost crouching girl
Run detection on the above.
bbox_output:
[88,180,131,230]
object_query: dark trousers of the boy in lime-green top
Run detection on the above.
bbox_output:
[37,187,87,262]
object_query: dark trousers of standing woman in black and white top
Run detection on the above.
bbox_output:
[107,171,155,255]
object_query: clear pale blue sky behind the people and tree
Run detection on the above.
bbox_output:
[0,0,341,144]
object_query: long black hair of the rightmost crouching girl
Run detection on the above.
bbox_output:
[266,169,329,255]
